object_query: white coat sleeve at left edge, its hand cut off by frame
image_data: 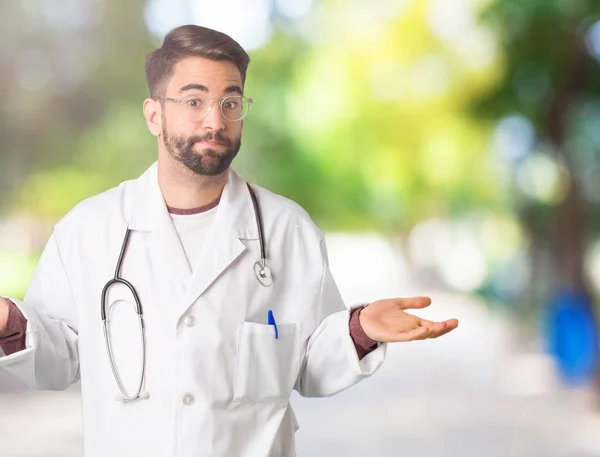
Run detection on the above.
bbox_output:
[0,235,79,390]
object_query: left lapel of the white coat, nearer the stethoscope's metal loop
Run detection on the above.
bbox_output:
[129,163,192,302]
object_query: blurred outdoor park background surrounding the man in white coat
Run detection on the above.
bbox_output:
[0,0,600,457]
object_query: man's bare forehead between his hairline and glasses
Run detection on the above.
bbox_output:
[167,57,242,93]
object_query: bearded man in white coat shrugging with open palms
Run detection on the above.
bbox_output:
[0,26,458,457]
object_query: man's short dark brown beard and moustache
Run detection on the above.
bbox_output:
[162,128,242,176]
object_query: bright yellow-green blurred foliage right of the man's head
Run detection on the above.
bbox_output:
[268,0,506,235]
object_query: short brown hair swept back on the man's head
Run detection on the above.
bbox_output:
[146,25,250,97]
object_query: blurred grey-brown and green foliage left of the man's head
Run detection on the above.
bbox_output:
[0,0,152,221]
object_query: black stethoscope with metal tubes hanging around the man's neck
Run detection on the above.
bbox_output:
[100,183,273,401]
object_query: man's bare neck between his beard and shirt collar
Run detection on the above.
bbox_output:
[158,161,229,210]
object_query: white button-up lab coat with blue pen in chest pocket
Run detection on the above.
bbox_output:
[0,163,386,457]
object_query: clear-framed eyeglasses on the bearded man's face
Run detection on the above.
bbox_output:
[156,95,254,122]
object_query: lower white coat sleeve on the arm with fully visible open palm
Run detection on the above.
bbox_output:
[295,235,387,397]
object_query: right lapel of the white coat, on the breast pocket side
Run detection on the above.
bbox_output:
[180,170,258,314]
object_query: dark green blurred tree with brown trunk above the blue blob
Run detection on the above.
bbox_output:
[475,0,600,388]
